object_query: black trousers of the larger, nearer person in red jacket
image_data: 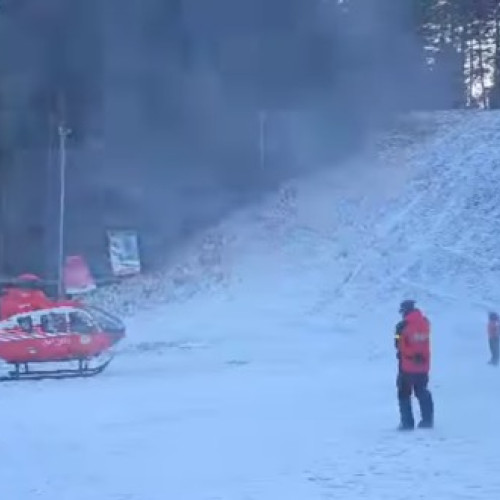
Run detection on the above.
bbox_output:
[397,372,434,427]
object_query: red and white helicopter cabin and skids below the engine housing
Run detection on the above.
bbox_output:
[0,276,125,382]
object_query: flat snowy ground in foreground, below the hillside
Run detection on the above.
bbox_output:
[0,292,500,500]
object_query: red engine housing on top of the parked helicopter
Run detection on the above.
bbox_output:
[0,274,53,319]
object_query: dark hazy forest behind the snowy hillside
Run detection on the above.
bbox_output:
[0,0,500,278]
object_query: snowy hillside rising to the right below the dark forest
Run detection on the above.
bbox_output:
[91,108,500,324]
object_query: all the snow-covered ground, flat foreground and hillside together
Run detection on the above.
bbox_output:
[0,113,500,500]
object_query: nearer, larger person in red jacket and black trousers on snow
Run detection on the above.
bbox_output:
[395,300,434,430]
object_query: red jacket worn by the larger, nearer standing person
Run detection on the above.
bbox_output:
[398,309,431,373]
